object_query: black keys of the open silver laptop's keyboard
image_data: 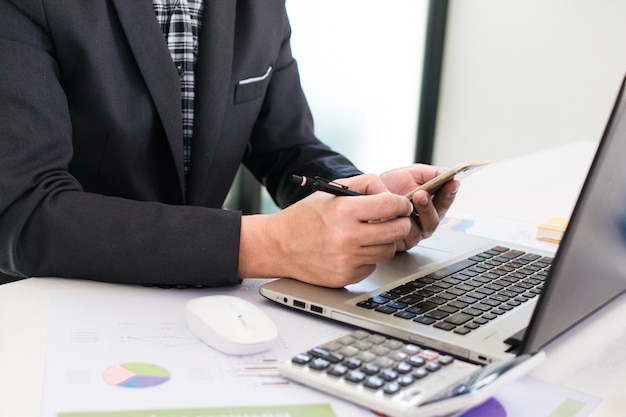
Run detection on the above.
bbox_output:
[357,246,553,335]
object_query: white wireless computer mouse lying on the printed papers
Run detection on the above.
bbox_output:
[185,295,278,355]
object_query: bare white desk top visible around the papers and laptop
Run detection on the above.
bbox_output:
[0,143,626,417]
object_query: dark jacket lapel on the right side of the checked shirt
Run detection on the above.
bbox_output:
[188,0,237,204]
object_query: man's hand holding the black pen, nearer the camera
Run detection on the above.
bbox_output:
[239,175,414,287]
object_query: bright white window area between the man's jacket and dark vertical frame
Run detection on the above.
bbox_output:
[287,0,427,173]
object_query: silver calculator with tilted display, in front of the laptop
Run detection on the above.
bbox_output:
[279,330,542,417]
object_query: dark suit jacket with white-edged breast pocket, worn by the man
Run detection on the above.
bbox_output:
[0,0,358,285]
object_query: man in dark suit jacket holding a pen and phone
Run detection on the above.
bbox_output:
[0,0,458,286]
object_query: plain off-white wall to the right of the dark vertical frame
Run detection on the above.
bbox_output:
[433,0,626,166]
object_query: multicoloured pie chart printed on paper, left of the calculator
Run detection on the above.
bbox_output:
[103,362,172,388]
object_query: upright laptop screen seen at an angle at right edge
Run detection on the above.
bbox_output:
[521,76,626,353]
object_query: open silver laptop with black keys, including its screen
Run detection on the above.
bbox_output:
[260,75,626,364]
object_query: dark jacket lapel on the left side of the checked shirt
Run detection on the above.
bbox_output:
[112,0,185,192]
